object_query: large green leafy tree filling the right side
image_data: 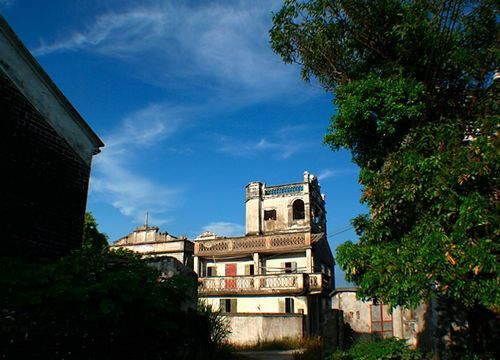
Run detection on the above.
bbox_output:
[270,0,500,351]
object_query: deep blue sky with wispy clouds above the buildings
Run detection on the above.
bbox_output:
[0,0,365,285]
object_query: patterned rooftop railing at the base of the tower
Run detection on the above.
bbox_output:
[194,233,311,256]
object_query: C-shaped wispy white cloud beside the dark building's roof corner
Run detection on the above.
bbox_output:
[91,104,186,225]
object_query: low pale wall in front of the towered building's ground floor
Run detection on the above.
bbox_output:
[226,313,304,345]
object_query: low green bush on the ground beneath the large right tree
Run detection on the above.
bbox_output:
[325,338,423,360]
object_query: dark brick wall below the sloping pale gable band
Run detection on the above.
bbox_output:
[0,71,90,258]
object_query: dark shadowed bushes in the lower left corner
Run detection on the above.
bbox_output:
[0,251,213,359]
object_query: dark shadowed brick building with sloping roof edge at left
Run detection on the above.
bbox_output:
[0,16,104,258]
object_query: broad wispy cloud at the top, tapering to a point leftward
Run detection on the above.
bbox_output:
[33,1,314,104]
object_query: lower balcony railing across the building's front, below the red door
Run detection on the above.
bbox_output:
[199,274,329,296]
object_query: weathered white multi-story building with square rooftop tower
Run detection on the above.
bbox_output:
[194,172,334,344]
